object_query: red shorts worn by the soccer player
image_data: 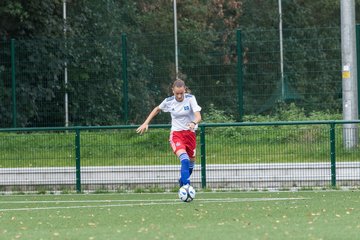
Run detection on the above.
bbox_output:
[169,130,196,158]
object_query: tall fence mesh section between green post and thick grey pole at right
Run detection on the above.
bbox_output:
[242,28,342,113]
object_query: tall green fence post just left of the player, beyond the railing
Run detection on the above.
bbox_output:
[121,33,129,124]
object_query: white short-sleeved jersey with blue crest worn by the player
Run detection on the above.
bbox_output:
[159,93,201,131]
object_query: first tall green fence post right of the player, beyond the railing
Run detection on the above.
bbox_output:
[236,29,244,122]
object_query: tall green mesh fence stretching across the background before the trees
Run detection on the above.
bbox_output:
[0,27,342,127]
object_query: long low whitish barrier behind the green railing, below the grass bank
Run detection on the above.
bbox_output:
[0,162,360,188]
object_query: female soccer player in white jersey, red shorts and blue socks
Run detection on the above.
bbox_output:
[136,79,201,186]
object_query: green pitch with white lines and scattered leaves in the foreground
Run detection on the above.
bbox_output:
[0,190,360,240]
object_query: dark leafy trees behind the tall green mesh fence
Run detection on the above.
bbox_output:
[0,0,360,127]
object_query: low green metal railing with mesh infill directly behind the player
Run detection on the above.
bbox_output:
[0,120,360,192]
